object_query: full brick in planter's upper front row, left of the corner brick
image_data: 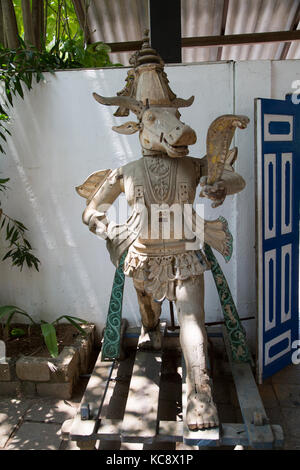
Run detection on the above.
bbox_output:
[16,357,50,382]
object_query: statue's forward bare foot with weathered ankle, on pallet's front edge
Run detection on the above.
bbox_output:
[186,381,219,431]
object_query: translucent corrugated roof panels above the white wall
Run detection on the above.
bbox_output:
[89,0,300,65]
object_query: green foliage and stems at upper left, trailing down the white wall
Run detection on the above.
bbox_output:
[0,0,121,270]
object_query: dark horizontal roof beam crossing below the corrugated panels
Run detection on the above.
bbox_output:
[108,30,300,52]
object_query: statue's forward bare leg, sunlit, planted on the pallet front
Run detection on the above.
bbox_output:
[176,275,218,430]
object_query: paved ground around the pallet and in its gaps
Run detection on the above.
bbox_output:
[0,338,300,450]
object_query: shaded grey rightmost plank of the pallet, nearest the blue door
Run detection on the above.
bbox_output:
[222,327,274,449]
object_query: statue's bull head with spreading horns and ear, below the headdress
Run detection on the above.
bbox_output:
[93,93,197,158]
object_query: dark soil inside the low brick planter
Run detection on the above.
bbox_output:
[0,323,80,357]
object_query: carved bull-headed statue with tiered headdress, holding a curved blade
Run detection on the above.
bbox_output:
[77,35,248,429]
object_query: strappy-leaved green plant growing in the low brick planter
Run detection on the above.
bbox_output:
[0,305,88,357]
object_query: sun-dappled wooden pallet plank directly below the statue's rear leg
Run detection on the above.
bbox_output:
[122,324,165,443]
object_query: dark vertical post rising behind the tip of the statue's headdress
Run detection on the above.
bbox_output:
[149,0,181,64]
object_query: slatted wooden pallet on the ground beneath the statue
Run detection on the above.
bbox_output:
[62,325,283,449]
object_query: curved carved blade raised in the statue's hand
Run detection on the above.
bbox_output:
[206,114,249,185]
